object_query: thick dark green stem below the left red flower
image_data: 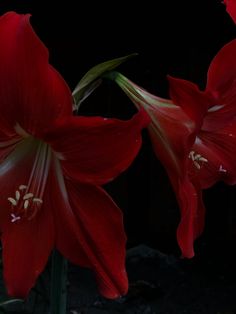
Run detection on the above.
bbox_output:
[50,250,67,314]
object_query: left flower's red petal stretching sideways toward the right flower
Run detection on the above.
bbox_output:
[44,112,149,185]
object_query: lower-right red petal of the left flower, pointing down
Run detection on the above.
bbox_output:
[52,162,128,298]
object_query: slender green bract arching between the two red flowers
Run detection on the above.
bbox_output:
[72,53,137,110]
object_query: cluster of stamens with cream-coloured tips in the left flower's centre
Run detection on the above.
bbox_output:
[7,141,51,222]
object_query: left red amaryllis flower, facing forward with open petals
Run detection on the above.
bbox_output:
[0,12,149,298]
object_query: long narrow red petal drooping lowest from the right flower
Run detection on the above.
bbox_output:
[149,112,204,258]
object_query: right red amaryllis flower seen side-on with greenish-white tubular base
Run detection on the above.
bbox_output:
[114,40,236,257]
